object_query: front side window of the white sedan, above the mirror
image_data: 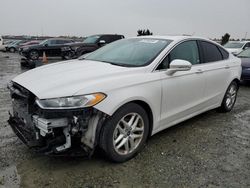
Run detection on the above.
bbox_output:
[156,41,200,70]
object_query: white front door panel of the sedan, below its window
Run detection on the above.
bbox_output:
[158,65,205,130]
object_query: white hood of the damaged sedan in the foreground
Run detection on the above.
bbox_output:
[12,60,144,99]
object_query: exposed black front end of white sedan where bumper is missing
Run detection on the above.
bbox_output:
[8,82,107,156]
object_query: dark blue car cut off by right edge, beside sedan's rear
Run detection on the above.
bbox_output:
[238,48,250,81]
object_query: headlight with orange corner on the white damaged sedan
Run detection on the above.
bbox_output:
[36,93,106,109]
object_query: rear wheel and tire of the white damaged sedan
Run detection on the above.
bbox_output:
[219,81,239,112]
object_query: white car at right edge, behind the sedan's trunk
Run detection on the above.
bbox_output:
[224,41,250,55]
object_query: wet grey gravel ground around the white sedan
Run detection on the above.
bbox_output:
[0,52,250,188]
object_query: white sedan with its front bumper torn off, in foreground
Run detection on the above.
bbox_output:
[8,36,241,162]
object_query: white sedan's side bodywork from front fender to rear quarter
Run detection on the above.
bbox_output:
[95,39,241,134]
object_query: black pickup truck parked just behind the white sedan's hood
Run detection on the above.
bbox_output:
[62,34,124,59]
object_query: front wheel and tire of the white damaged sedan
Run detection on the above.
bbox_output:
[99,103,149,162]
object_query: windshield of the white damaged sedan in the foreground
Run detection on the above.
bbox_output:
[85,38,171,67]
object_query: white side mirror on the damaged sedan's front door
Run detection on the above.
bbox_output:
[166,59,192,75]
